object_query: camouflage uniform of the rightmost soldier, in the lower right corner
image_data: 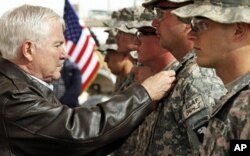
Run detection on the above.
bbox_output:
[201,72,250,156]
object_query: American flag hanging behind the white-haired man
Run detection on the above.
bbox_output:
[63,0,100,90]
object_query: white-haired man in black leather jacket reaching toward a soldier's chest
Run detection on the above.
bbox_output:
[0,5,175,156]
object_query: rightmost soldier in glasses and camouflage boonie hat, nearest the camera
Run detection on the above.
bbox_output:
[174,0,250,156]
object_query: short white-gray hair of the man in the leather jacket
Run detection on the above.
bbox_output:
[0,5,65,60]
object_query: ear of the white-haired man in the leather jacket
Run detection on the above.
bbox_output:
[21,40,35,61]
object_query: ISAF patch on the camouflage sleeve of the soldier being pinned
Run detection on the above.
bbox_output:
[183,95,205,119]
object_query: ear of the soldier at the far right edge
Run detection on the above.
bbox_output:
[234,23,249,41]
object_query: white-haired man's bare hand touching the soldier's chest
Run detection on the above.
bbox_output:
[141,70,175,101]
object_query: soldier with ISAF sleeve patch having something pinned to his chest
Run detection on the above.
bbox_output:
[131,0,225,156]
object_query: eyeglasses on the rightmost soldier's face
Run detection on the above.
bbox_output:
[191,17,208,33]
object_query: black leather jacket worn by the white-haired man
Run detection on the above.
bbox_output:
[0,59,153,156]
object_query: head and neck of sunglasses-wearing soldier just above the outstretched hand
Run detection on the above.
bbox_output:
[127,9,176,77]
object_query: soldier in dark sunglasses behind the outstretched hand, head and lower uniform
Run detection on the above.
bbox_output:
[113,9,178,156]
